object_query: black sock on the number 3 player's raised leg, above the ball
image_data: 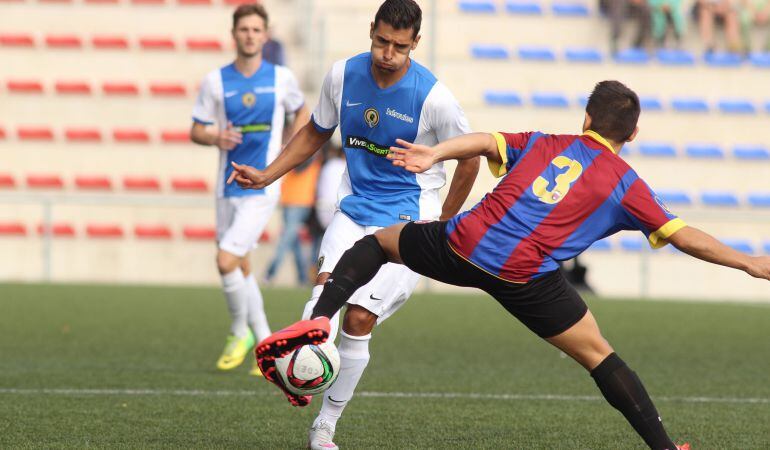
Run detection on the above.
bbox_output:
[311,235,388,319]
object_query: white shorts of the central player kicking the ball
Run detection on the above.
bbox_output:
[318,211,421,324]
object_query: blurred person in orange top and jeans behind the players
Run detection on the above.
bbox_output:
[265,158,321,285]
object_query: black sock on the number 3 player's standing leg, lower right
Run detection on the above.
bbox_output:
[591,353,676,450]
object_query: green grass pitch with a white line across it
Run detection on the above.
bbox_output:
[0,285,770,449]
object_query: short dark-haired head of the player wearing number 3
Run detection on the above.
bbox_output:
[586,81,642,143]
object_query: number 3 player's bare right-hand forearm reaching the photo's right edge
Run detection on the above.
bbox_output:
[667,226,770,280]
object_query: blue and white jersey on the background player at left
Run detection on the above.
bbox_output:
[193,60,305,197]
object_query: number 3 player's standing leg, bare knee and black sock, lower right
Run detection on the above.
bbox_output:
[546,311,677,450]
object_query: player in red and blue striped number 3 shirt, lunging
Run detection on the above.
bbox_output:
[257,81,770,450]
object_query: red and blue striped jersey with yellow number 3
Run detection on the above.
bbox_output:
[447,131,685,282]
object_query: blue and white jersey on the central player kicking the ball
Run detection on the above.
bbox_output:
[312,52,470,227]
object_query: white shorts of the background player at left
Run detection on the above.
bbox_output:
[217,195,278,257]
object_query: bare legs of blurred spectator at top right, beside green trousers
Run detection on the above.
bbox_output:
[695,0,742,54]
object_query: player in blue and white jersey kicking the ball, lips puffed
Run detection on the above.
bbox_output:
[233,0,479,449]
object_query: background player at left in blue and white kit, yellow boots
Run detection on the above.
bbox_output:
[190,5,310,375]
